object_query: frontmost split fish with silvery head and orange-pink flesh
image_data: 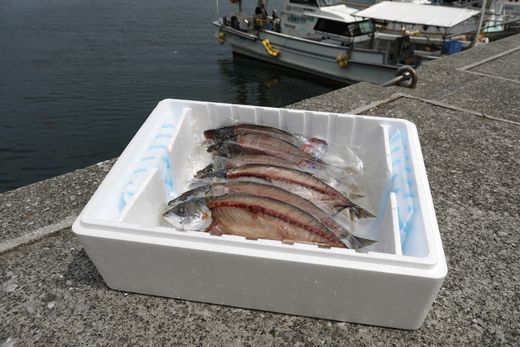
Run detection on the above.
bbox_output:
[164,193,346,248]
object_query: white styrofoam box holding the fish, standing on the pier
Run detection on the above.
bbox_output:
[73,100,447,329]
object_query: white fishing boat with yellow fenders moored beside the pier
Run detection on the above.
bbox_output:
[213,0,478,84]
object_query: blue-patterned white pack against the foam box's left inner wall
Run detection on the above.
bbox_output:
[118,122,176,212]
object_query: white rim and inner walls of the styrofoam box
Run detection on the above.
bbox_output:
[73,99,447,278]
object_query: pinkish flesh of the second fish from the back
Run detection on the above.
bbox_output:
[208,134,319,165]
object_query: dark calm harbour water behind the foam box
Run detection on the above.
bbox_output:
[0,0,338,191]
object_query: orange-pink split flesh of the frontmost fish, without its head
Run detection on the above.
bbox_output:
[207,193,346,248]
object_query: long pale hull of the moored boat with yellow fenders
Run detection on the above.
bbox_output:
[215,27,398,84]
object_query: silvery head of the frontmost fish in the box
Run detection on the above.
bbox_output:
[163,197,212,231]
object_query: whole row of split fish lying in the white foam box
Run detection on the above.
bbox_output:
[163,124,374,249]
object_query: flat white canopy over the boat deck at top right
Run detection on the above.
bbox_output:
[353,1,480,28]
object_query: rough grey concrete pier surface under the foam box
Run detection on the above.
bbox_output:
[0,35,520,346]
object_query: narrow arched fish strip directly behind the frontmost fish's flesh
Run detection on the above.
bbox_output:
[168,181,366,249]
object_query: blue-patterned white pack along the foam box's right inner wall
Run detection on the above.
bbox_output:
[390,129,415,247]
